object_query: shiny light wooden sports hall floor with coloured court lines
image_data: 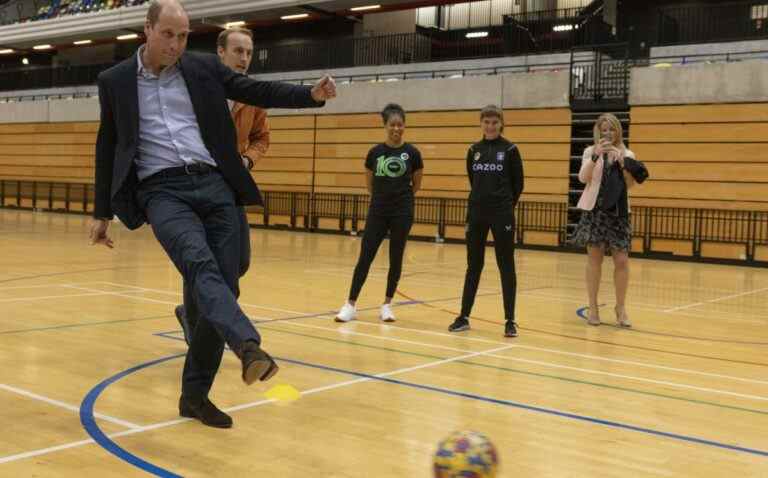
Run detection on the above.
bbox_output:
[0,210,768,478]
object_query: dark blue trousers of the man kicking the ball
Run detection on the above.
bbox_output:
[137,172,261,397]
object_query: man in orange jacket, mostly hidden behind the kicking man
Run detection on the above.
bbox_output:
[175,28,269,344]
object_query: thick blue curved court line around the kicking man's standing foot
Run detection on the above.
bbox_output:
[80,352,186,478]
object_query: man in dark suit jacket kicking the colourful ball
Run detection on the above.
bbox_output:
[91,0,336,428]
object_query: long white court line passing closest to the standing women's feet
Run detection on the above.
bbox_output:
[99,282,768,384]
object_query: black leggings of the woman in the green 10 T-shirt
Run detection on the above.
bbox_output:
[349,214,413,300]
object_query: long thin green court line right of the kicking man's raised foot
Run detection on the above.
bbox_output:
[259,325,768,415]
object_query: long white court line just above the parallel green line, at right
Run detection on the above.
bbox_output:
[270,321,768,402]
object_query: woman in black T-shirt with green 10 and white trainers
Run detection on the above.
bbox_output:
[336,104,424,322]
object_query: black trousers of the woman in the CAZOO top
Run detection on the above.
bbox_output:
[461,212,517,321]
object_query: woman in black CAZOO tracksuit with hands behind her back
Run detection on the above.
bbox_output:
[448,105,523,337]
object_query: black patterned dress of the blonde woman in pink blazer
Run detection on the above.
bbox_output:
[570,158,632,255]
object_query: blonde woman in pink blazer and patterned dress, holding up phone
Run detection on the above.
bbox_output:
[572,113,635,327]
